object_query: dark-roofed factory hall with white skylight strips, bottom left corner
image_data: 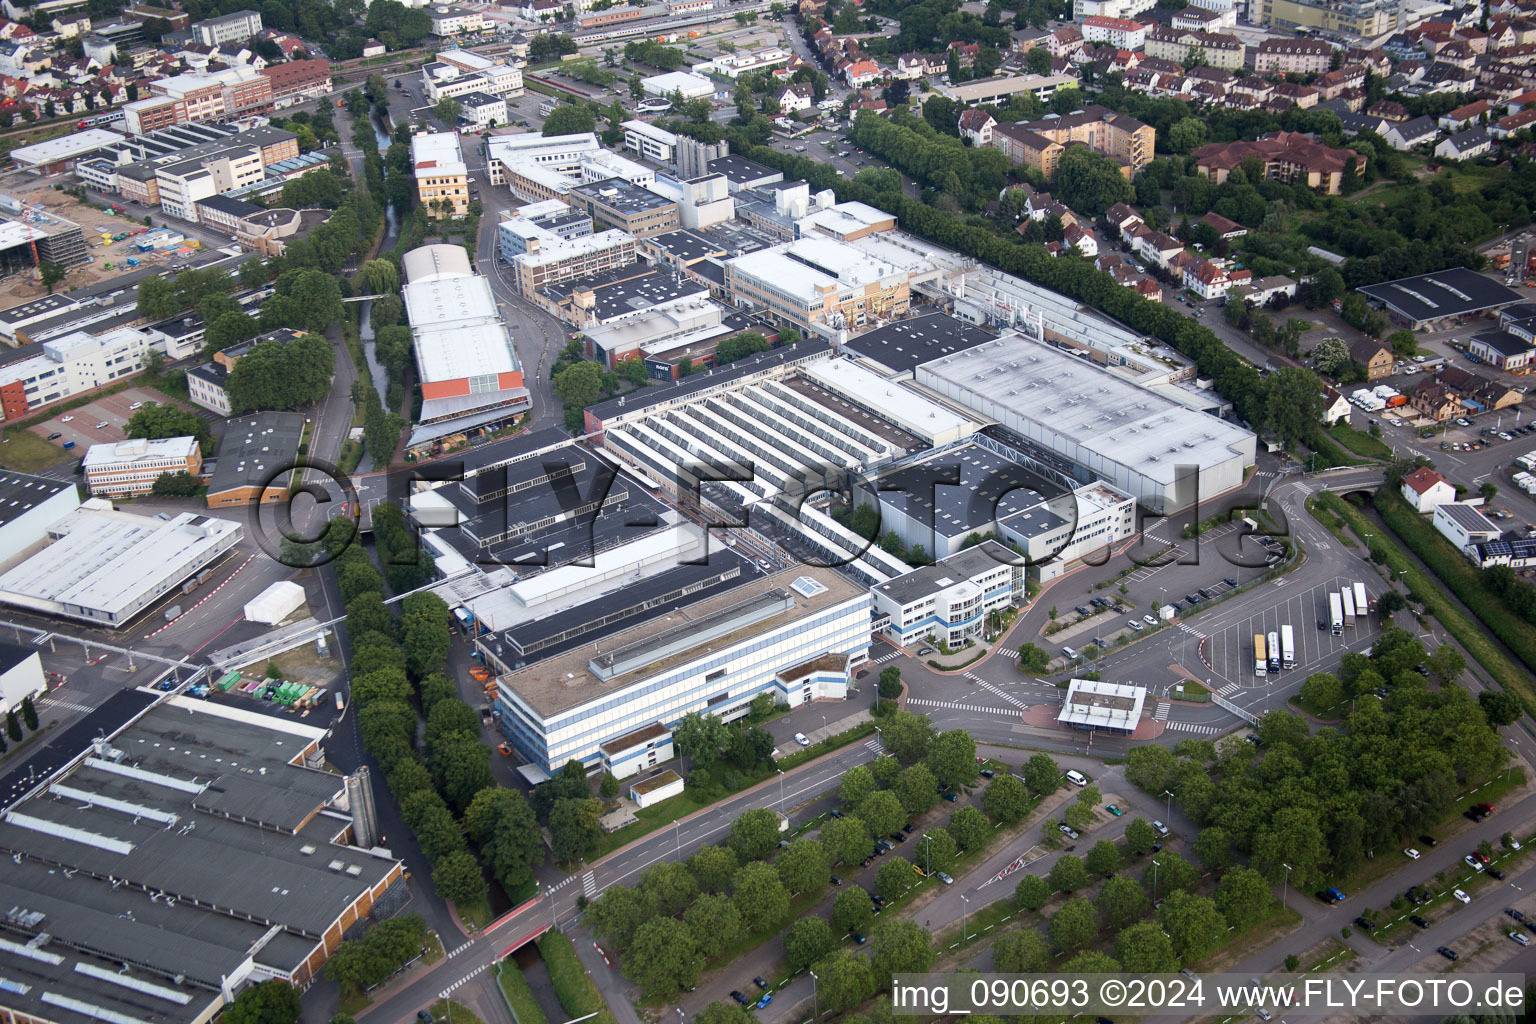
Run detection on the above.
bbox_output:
[0,692,406,1024]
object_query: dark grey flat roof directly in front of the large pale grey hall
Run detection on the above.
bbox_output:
[874,444,1061,537]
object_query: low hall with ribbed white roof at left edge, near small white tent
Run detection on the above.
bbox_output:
[0,502,244,628]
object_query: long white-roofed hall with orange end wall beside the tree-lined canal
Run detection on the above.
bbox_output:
[401,244,530,453]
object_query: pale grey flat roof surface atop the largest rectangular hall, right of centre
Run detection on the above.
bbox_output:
[917,333,1255,484]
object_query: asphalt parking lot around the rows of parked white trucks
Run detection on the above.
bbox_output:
[1186,576,1379,689]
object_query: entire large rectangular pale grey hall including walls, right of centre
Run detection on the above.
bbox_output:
[917,335,1256,514]
